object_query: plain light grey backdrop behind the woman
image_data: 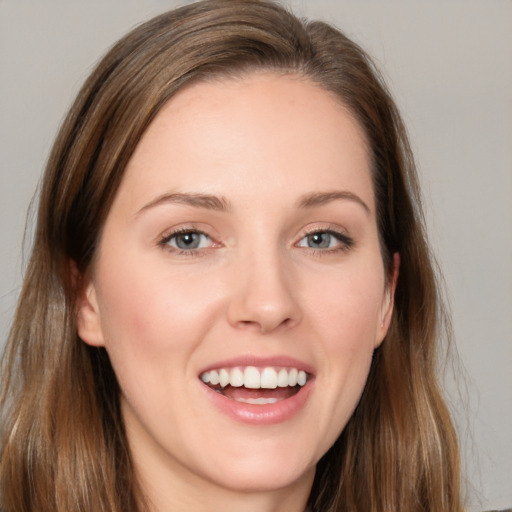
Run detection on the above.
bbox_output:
[0,0,512,511]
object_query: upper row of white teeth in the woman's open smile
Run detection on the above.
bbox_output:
[200,366,308,390]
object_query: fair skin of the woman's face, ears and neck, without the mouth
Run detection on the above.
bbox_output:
[79,73,398,512]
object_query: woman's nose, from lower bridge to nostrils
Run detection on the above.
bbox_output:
[227,253,302,334]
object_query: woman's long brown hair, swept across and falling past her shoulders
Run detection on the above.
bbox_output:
[0,0,461,512]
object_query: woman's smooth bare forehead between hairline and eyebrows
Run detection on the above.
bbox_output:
[119,72,373,211]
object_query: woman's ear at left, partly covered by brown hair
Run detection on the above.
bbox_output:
[72,266,104,347]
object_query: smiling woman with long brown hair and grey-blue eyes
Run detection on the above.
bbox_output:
[0,0,461,512]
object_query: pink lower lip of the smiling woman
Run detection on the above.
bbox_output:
[200,380,313,425]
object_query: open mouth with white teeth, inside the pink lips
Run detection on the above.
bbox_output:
[199,366,310,405]
